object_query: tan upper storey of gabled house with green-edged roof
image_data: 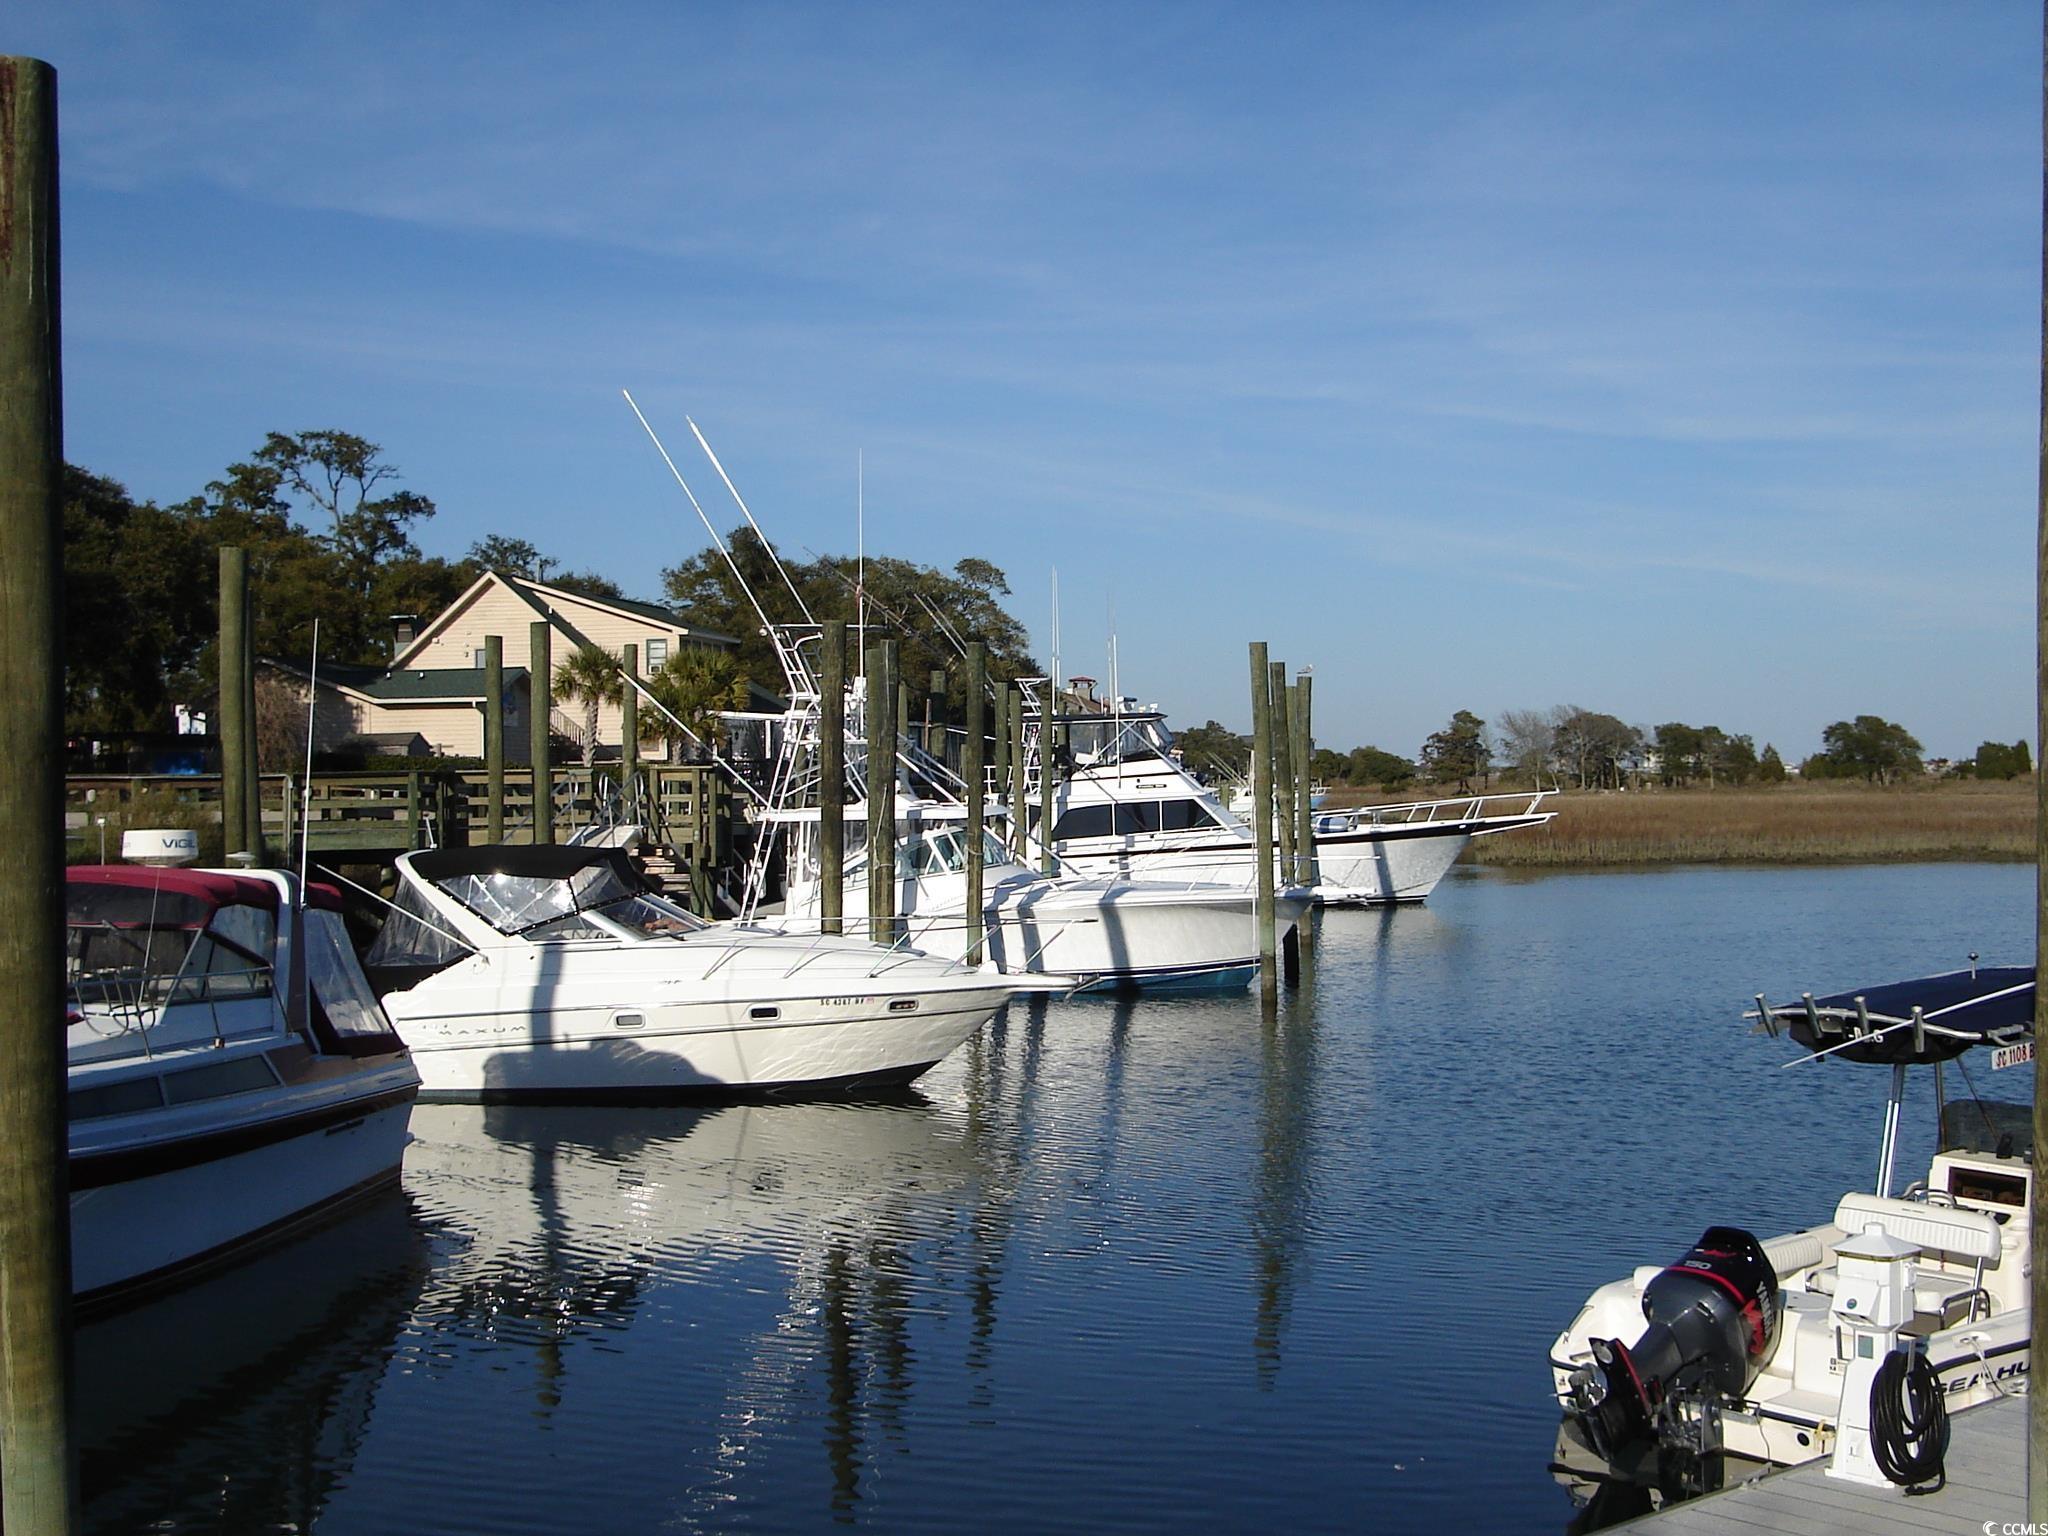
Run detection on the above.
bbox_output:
[387,571,739,762]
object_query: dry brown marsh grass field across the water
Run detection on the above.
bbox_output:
[1327,778,2034,868]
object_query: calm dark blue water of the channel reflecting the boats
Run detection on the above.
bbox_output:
[80,864,2034,1536]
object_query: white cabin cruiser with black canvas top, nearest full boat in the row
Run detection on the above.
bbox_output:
[365,846,1032,1100]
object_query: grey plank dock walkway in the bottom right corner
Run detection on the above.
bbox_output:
[1616,1397,2028,1536]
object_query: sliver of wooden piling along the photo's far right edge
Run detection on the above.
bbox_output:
[2028,6,2048,1526]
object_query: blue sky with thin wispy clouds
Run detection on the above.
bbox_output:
[16,0,2042,758]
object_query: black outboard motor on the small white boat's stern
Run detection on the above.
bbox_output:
[1571,1227,1782,1462]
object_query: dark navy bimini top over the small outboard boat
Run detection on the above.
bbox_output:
[1763,965,2034,1067]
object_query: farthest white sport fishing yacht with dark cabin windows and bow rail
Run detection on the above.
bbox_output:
[1032,713,1556,905]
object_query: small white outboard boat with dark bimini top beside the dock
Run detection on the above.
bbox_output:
[1550,967,2034,1497]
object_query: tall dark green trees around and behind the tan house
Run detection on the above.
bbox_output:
[63,428,1036,737]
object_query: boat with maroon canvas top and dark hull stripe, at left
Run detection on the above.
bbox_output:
[66,864,420,1300]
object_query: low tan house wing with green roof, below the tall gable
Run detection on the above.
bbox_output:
[256,659,530,762]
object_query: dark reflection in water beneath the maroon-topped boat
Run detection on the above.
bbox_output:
[76,1188,428,1532]
